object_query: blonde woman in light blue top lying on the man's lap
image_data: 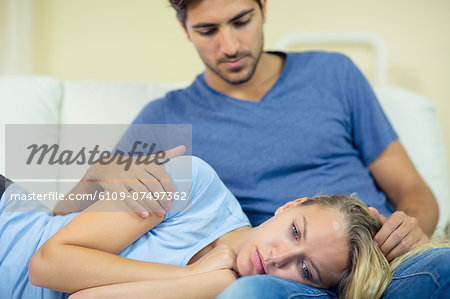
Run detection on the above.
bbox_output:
[0,157,448,298]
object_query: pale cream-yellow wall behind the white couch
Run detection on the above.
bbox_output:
[0,0,450,171]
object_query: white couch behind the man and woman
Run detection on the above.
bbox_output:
[0,76,450,234]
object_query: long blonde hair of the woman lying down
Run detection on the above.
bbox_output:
[301,195,450,299]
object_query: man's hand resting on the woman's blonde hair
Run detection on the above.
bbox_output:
[369,207,429,261]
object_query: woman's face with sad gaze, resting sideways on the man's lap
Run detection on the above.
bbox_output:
[237,199,349,288]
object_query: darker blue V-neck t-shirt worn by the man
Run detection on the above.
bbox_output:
[134,52,397,225]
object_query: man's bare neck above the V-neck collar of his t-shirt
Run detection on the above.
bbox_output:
[206,53,285,102]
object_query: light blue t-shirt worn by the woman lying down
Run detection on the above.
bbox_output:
[0,156,250,299]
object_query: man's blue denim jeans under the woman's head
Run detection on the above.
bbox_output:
[217,248,450,299]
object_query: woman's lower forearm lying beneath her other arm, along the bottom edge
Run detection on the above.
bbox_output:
[69,270,237,299]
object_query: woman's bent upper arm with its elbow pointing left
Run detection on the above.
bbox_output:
[29,196,189,293]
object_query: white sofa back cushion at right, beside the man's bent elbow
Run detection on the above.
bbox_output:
[376,87,450,232]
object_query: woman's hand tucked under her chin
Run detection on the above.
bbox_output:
[186,245,239,274]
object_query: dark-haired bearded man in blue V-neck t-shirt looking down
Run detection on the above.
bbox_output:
[72,0,444,298]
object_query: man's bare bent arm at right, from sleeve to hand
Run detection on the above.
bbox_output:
[369,140,439,259]
